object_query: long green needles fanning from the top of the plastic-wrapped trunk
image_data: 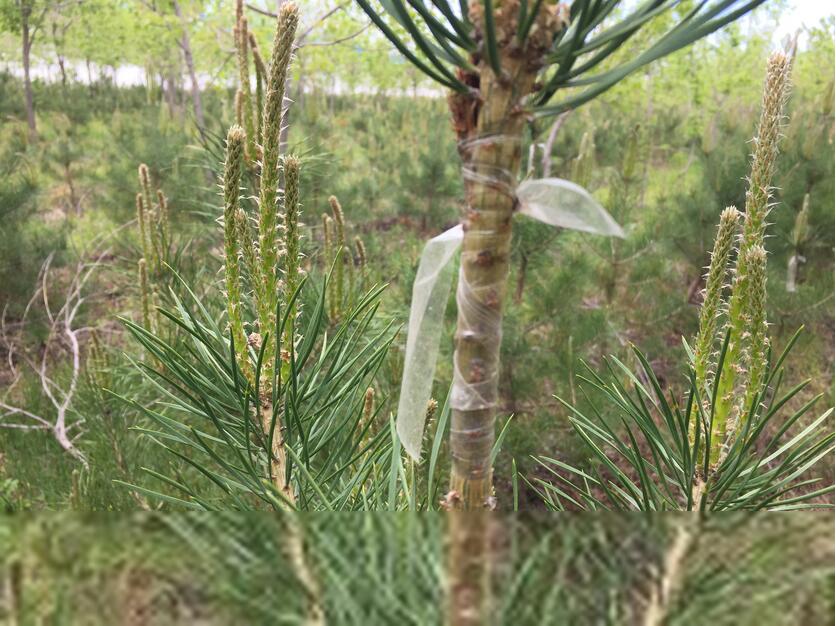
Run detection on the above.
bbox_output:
[357,0,762,115]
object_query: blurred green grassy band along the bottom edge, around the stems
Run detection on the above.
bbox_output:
[0,513,834,626]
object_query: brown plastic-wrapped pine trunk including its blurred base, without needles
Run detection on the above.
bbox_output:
[447,0,562,626]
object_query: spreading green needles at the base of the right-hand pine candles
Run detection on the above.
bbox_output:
[535,330,834,511]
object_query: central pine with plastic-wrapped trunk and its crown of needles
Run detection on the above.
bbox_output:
[357,0,762,626]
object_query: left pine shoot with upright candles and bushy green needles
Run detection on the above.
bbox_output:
[119,3,416,510]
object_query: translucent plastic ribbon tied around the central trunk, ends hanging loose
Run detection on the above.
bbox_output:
[397,176,624,460]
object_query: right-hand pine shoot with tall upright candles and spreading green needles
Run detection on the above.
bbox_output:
[535,53,834,510]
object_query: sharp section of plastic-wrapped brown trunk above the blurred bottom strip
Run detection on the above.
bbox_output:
[450,58,535,510]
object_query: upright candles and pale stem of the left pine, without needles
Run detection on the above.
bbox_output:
[223,3,300,503]
